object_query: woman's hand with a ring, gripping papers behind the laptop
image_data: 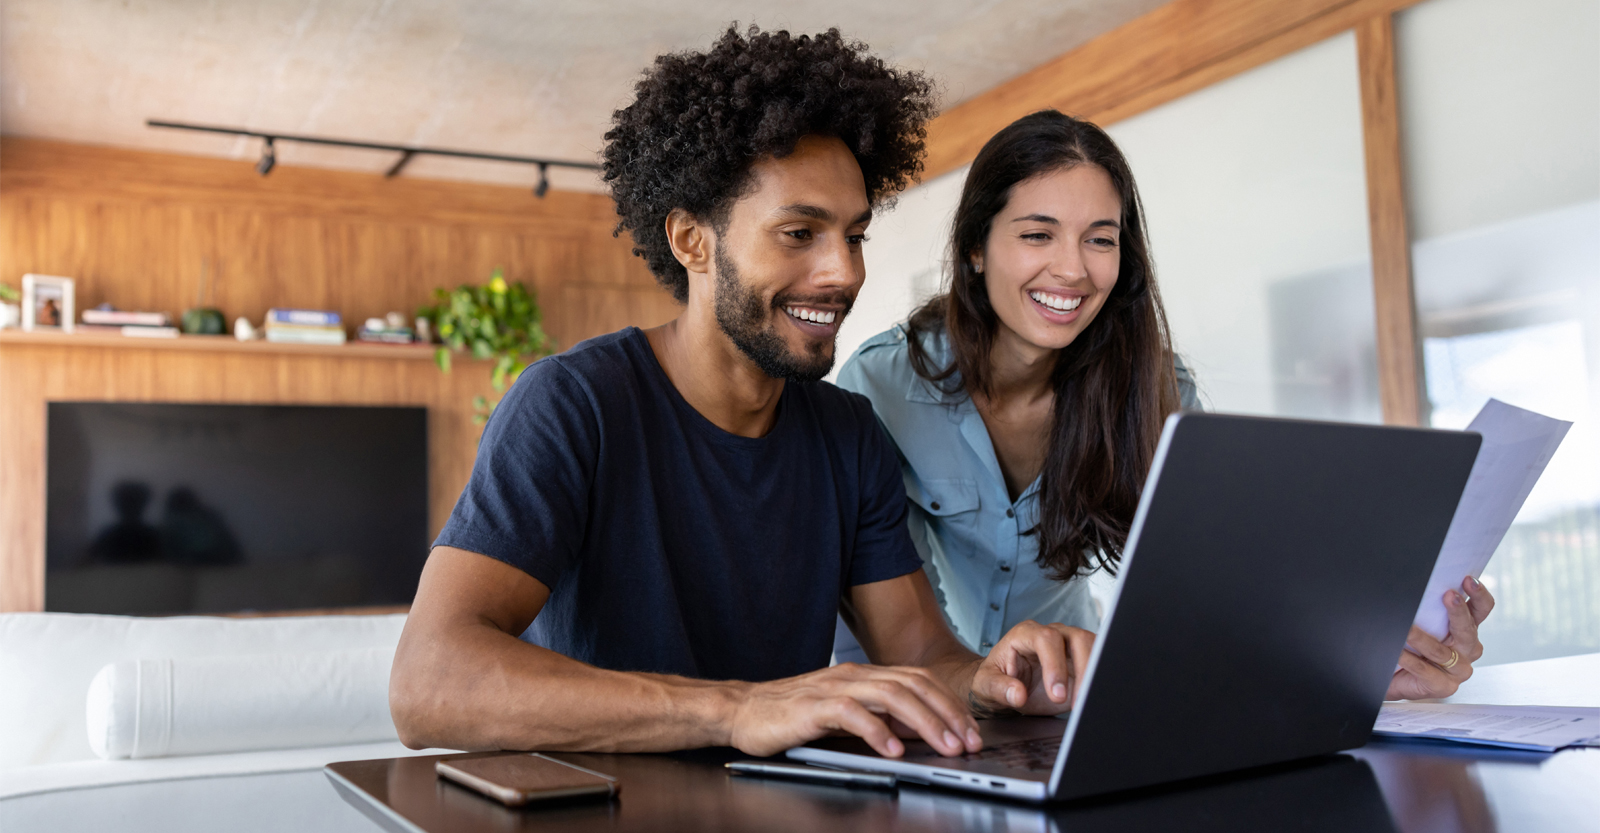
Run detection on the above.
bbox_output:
[1384,576,1494,700]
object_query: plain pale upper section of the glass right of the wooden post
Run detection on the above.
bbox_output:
[1395,0,1600,240]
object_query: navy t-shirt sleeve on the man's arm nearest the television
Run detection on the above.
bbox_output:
[434,360,600,587]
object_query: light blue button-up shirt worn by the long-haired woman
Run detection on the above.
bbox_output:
[834,326,1198,662]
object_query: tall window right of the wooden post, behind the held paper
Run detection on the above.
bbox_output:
[1395,0,1600,664]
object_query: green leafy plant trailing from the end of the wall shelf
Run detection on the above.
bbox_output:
[416,269,555,425]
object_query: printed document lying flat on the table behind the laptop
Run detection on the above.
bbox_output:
[1373,703,1600,751]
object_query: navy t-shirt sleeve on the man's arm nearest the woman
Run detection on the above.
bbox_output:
[850,398,922,587]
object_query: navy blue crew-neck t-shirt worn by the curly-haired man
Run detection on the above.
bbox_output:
[434,328,922,681]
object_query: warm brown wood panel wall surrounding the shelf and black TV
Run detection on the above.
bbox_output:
[0,138,678,611]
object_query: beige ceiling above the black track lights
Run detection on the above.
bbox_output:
[0,0,1165,190]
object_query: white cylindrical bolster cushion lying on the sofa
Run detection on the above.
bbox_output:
[88,648,398,759]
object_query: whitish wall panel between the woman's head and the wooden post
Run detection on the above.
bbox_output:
[1109,34,1379,420]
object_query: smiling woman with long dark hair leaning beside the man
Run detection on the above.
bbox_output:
[835,110,1493,697]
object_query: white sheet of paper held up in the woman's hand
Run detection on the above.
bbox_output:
[1416,400,1573,640]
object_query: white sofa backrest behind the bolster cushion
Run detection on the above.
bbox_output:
[0,612,405,769]
